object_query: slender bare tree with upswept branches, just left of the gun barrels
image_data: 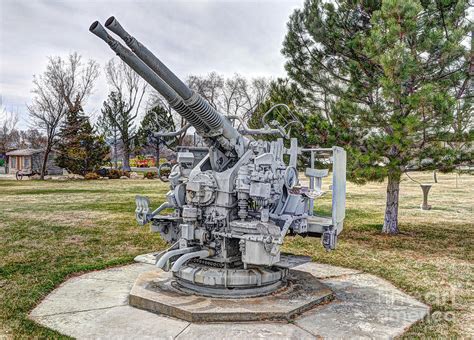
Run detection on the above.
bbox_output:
[104,59,147,171]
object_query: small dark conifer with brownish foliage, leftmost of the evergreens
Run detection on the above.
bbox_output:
[56,110,109,175]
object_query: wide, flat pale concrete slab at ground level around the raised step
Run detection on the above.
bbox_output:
[30,256,429,340]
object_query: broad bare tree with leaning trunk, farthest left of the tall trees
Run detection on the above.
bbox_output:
[28,52,99,179]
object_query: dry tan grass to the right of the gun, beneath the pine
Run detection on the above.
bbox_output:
[285,173,474,337]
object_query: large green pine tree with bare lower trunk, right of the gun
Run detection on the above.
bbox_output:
[267,0,473,234]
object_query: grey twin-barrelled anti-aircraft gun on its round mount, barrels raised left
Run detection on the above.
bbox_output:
[90,17,346,297]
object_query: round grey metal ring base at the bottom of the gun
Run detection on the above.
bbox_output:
[173,262,289,298]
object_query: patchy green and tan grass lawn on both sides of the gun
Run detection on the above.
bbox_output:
[0,174,474,338]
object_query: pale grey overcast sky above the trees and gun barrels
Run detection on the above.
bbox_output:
[0,0,303,128]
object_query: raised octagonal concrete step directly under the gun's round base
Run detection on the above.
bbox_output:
[129,270,333,322]
